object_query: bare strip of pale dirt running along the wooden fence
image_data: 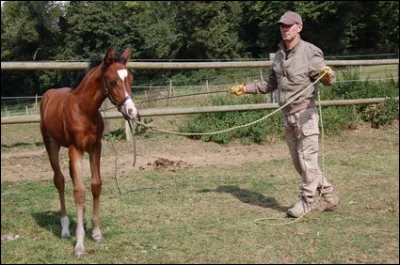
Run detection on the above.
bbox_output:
[1,121,399,182]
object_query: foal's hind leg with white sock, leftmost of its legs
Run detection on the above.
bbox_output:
[44,135,71,238]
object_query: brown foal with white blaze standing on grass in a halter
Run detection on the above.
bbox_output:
[40,48,138,259]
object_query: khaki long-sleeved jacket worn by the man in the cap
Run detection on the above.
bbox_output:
[246,40,336,114]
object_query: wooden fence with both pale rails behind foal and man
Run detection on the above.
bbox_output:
[1,59,399,139]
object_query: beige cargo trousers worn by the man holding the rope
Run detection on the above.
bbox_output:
[284,107,333,200]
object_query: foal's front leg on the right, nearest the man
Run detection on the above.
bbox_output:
[89,141,103,242]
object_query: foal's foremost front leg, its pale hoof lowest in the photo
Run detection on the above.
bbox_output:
[68,146,86,258]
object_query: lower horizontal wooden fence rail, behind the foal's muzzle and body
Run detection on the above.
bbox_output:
[1,98,398,124]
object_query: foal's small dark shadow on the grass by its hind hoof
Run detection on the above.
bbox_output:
[32,211,76,238]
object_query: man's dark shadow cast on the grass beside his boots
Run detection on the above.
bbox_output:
[199,185,288,212]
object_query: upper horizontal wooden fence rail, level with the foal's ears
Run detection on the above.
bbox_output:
[1,59,399,70]
